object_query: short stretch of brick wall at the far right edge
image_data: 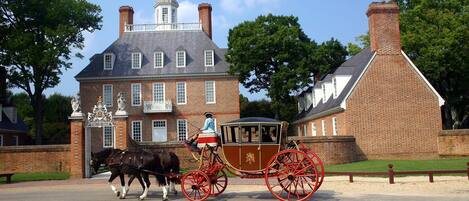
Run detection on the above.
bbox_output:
[438,129,469,156]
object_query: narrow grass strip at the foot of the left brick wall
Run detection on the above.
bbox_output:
[0,172,70,184]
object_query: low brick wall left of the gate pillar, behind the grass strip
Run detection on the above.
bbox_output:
[0,145,70,172]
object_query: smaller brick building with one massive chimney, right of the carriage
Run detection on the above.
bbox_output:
[293,3,444,159]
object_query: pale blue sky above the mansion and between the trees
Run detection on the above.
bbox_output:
[35,0,372,100]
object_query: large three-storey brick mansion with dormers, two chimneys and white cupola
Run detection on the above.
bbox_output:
[75,0,239,151]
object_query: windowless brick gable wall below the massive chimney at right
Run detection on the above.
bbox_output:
[345,54,441,159]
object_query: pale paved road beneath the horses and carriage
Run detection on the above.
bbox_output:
[0,177,469,201]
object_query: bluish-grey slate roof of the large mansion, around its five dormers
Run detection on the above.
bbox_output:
[75,31,229,81]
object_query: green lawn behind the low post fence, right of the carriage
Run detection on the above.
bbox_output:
[325,158,469,172]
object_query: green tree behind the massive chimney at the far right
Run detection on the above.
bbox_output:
[397,0,469,128]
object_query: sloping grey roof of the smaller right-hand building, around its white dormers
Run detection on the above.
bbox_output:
[294,48,374,123]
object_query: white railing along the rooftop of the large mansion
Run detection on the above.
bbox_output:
[124,23,202,32]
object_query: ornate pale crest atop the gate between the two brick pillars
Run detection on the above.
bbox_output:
[87,96,113,128]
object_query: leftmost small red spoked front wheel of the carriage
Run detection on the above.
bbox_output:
[181,170,211,201]
